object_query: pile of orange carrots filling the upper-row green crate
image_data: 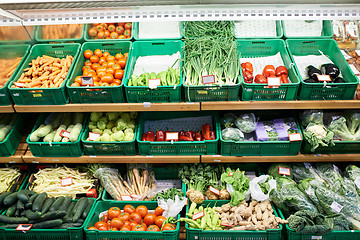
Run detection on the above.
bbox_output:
[11,55,74,88]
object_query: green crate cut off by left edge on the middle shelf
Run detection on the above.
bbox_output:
[0,114,25,158]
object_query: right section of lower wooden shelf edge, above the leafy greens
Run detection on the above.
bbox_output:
[201,154,360,163]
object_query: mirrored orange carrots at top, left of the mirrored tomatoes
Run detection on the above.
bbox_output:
[41,24,83,39]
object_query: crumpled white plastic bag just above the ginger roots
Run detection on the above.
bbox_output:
[250,175,276,202]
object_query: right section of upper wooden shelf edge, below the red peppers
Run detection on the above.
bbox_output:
[201,100,360,110]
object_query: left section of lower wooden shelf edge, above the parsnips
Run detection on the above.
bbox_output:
[23,150,200,163]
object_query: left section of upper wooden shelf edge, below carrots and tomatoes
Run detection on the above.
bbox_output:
[14,102,200,112]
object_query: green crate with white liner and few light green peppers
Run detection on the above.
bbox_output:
[124,40,184,103]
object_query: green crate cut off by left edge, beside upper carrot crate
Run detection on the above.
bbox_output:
[0,44,30,106]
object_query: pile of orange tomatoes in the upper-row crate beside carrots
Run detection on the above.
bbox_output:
[70,49,128,87]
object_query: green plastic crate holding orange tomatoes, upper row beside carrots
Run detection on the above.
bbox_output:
[66,41,131,103]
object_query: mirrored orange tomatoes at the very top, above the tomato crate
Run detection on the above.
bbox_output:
[87,22,132,39]
